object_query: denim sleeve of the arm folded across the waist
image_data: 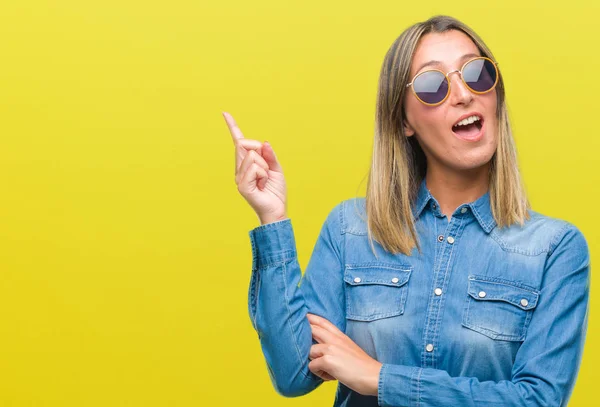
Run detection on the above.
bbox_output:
[377,224,590,407]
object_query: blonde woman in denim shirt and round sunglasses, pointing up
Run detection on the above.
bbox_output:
[224,16,590,407]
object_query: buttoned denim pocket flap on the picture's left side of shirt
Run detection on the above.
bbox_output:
[344,263,412,287]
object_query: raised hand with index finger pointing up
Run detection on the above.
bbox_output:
[223,112,287,225]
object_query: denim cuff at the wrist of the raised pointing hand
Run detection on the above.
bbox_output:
[248,218,296,270]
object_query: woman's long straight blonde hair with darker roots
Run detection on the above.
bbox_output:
[366,16,530,255]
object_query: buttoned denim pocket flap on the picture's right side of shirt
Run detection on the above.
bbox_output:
[469,276,539,310]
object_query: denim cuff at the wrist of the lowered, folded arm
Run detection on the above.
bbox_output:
[377,363,423,407]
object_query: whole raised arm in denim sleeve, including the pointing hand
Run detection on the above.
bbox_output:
[223,112,345,397]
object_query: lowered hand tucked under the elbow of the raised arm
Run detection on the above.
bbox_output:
[306,314,382,396]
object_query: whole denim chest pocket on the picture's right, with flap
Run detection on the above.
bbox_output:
[462,275,539,341]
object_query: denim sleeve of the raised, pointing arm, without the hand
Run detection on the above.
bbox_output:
[248,203,345,397]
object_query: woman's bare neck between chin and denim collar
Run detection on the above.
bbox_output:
[425,163,489,221]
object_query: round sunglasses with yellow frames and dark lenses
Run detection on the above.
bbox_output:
[406,57,499,106]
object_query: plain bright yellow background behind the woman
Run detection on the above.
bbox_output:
[0,0,600,407]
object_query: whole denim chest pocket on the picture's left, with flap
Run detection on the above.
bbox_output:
[344,262,412,321]
